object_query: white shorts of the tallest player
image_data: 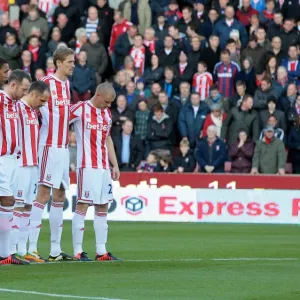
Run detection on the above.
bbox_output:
[38,146,70,190]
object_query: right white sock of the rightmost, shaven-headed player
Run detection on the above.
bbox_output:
[94,211,108,255]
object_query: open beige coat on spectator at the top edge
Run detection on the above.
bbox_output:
[123,0,152,35]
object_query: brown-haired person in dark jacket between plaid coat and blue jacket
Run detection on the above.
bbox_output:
[147,104,173,150]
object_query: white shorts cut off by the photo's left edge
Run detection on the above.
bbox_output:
[0,155,17,197]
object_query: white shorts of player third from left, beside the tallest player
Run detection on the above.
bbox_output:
[15,166,39,205]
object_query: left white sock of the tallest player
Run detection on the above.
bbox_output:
[28,201,45,253]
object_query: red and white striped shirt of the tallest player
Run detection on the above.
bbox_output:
[40,75,71,148]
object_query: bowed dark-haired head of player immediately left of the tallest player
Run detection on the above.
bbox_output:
[26,81,50,109]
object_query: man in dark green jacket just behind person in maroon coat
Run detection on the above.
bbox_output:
[221,95,260,146]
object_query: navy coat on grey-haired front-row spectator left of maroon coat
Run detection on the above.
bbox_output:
[195,137,227,173]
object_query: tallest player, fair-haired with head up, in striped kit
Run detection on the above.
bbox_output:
[28,47,75,261]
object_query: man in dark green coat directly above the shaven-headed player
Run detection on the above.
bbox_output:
[81,32,108,84]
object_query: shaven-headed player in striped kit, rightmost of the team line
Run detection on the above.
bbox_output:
[70,82,120,261]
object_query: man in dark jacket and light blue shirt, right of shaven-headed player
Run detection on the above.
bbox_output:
[113,119,144,172]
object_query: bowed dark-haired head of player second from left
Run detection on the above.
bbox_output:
[7,70,32,100]
